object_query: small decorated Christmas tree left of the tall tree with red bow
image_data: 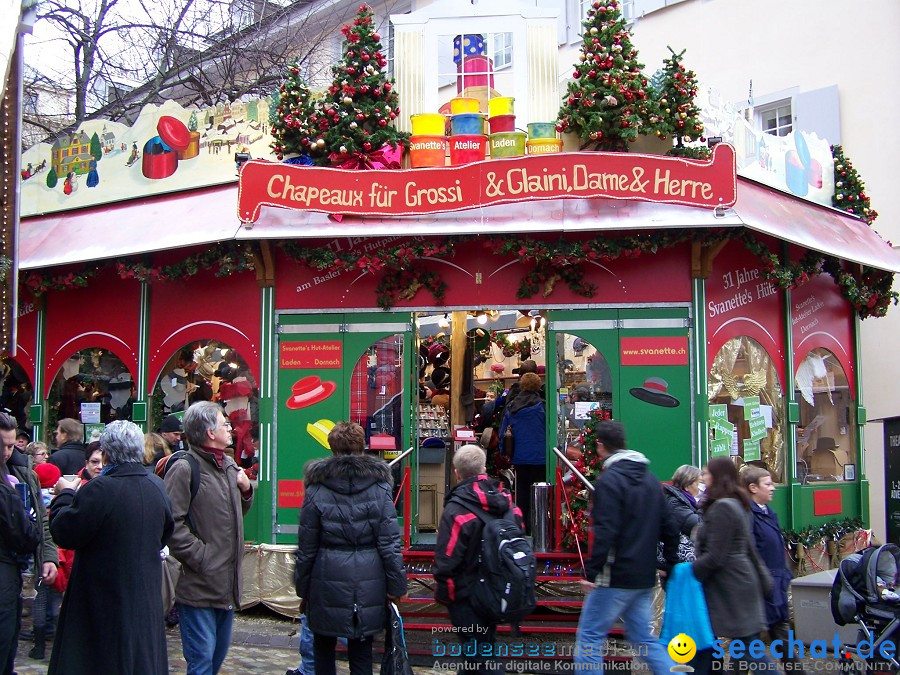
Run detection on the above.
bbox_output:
[270,62,328,164]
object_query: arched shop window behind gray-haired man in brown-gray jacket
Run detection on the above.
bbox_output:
[149,340,259,470]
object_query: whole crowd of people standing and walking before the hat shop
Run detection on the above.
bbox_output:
[0,402,796,675]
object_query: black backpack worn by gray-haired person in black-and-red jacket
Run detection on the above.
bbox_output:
[450,497,537,626]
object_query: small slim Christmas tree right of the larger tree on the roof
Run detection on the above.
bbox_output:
[656,47,709,159]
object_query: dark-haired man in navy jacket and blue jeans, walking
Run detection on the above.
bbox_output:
[575,420,678,675]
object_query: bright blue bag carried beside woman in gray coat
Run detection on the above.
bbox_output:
[659,563,716,651]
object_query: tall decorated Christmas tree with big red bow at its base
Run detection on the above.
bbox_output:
[323,5,409,168]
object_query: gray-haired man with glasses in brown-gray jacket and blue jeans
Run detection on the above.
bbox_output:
[165,401,253,675]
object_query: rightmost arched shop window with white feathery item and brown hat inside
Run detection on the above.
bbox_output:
[794,348,856,483]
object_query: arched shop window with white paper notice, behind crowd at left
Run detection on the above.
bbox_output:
[47,348,135,434]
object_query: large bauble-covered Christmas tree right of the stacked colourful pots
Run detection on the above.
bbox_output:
[556,0,660,152]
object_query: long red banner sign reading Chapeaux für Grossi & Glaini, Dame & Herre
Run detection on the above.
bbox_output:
[238,143,737,222]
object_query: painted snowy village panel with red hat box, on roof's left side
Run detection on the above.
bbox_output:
[21,99,274,216]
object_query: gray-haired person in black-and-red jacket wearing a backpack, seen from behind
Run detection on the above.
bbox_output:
[434,445,523,672]
